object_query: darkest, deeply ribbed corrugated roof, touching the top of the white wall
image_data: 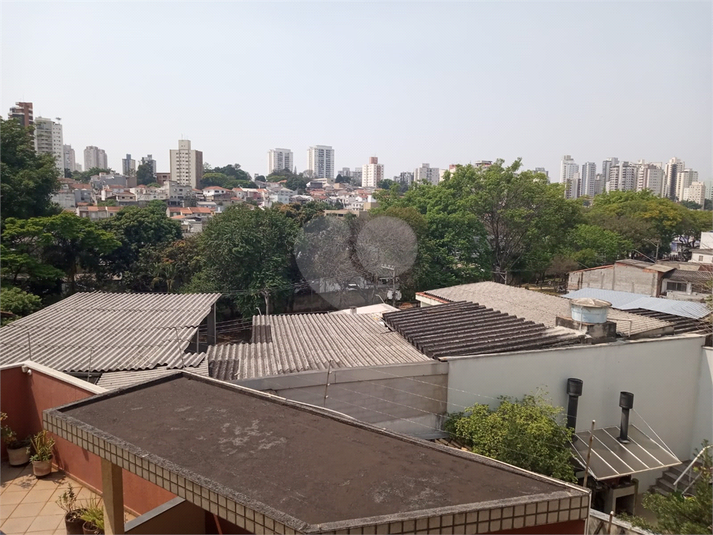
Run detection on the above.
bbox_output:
[384,301,584,358]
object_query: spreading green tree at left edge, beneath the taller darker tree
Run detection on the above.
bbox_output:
[2,212,119,292]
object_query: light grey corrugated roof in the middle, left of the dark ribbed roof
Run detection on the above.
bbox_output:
[207,314,431,381]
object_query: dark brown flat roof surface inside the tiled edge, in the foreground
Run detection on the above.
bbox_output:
[59,374,584,525]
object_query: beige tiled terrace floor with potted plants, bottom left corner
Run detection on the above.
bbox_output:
[0,462,133,535]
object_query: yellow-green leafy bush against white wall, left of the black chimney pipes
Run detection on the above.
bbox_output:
[445,393,577,483]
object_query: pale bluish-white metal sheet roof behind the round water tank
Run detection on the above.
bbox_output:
[565,288,711,319]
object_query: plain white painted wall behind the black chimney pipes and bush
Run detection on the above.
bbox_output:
[447,335,713,460]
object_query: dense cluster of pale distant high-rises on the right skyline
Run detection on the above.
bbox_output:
[560,154,706,206]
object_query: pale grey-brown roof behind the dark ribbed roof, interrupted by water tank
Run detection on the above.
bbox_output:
[423,282,670,336]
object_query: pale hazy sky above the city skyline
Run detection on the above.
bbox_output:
[0,1,713,180]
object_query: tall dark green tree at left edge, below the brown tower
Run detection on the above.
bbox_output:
[0,119,61,222]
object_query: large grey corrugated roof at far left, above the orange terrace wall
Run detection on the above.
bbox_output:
[0,292,220,372]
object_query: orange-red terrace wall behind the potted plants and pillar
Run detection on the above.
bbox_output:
[0,367,176,515]
